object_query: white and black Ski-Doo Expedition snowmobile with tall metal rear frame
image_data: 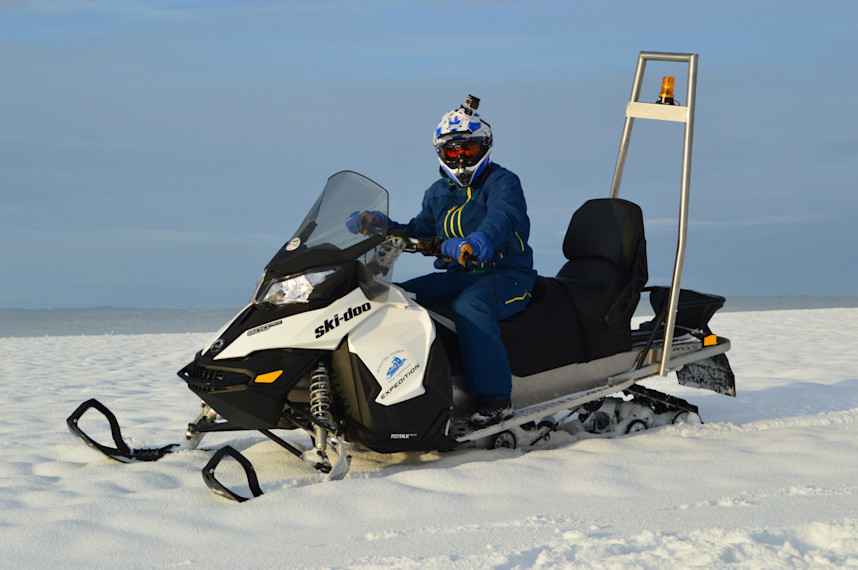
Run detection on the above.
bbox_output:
[67,52,735,501]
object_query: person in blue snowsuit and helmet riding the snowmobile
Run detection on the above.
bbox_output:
[348,96,536,429]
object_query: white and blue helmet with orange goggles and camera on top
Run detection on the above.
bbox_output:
[432,95,492,186]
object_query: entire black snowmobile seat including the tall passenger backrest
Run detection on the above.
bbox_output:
[501,198,648,376]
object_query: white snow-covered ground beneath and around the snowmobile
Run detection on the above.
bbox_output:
[0,308,858,569]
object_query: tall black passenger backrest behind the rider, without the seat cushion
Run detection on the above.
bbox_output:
[557,198,649,328]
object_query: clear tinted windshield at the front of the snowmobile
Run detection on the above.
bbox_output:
[286,171,388,251]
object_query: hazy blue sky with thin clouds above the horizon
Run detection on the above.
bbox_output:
[0,0,858,309]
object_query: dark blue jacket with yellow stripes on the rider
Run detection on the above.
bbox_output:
[406,163,535,274]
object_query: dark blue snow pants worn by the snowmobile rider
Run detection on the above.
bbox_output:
[402,269,536,402]
